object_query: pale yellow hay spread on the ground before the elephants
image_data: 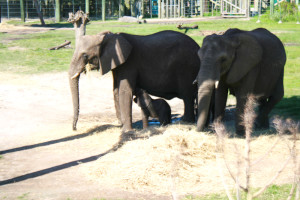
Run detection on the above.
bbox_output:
[83,124,293,195]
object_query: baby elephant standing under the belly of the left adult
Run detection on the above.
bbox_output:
[133,89,171,128]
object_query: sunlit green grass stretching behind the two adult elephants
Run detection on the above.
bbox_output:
[0,15,300,120]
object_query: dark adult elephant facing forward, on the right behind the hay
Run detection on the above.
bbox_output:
[196,28,286,135]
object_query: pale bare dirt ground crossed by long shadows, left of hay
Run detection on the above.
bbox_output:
[0,70,181,199]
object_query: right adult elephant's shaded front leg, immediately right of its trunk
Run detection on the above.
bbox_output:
[214,82,228,121]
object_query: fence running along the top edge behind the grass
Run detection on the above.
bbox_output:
[0,0,300,20]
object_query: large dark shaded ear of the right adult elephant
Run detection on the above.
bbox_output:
[226,34,263,84]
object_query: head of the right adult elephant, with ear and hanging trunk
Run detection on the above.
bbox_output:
[196,29,262,131]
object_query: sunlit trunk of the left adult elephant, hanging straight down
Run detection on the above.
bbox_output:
[69,69,79,131]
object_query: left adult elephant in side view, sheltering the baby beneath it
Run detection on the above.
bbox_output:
[69,31,200,132]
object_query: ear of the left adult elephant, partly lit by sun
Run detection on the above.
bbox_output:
[99,32,132,75]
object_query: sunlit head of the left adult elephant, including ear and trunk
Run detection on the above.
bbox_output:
[69,32,132,130]
